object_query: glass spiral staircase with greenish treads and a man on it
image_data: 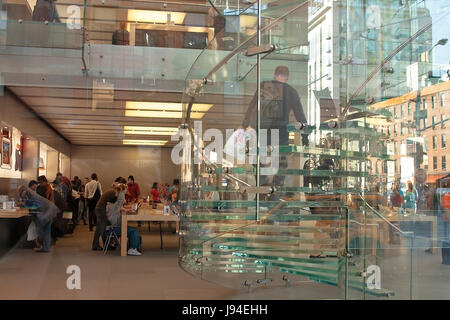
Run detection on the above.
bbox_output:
[179,0,446,299]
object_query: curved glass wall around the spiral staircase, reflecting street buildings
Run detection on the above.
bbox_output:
[176,0,450,299]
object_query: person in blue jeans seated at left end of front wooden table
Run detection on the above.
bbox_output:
[106,181,142,256]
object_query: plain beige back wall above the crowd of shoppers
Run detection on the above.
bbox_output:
[70,146,180,195]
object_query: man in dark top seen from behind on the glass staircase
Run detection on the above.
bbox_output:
[242,66,308,187]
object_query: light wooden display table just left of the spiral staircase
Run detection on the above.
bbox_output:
[120,203,180,257]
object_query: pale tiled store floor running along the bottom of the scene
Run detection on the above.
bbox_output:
[0,224,450,300]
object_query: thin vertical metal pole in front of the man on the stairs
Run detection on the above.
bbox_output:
[256,0,261,221]
